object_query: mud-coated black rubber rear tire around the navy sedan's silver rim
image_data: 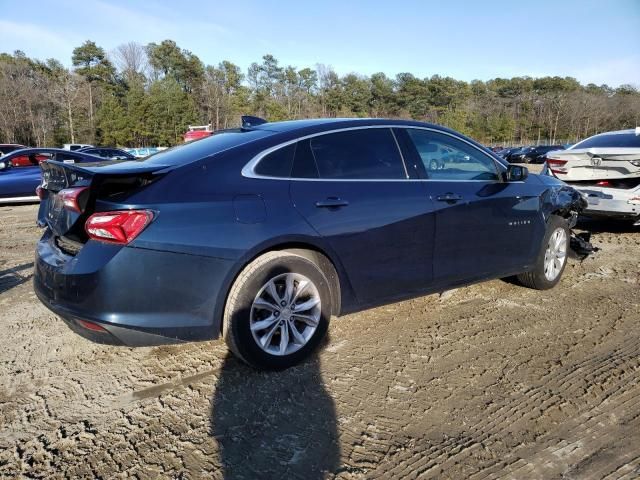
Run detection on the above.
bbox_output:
[229,254,332,370]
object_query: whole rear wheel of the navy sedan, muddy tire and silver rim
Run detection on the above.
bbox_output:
[222,251,332,370]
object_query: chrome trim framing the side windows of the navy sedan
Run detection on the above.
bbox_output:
[241,125,507,183]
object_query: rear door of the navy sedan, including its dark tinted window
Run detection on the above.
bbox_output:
[290,128,434,304]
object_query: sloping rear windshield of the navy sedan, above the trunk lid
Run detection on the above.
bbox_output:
[143,129,273,165]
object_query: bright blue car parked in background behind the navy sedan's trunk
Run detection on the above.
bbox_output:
[0,148,102,204]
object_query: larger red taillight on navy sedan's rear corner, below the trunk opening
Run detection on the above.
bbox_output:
[84,210,153,245]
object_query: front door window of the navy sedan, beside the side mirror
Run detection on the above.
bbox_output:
[407,128,499,181]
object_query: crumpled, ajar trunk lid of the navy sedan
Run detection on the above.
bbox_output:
[38,160,170,239]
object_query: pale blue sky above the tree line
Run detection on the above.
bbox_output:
[0,0,640,86]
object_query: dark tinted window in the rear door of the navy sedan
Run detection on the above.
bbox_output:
[309,128,407,180]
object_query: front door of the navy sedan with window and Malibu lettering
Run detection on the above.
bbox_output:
[398,128,544,284]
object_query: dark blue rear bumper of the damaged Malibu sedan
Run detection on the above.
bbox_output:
[34,230,232,346]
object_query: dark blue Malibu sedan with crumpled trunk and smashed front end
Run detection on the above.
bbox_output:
[34,118,585,369]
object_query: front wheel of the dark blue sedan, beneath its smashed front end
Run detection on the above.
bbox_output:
[517,215,571,290]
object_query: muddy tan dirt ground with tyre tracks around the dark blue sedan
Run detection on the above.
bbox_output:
[0,201,640,479]
